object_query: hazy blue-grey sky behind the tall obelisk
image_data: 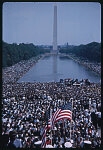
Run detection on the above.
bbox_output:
[2,2,101,45]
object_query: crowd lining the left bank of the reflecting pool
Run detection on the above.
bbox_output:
[2,55,42,83]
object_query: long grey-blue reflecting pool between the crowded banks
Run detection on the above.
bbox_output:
[18,55,100,83]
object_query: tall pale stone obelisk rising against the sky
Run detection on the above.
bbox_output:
[53,4,57,51]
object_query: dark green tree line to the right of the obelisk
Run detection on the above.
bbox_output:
[60,42,101,62]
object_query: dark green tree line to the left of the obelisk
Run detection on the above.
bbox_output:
[2,42,50,67]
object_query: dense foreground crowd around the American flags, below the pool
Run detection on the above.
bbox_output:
[2,79,101,148]
